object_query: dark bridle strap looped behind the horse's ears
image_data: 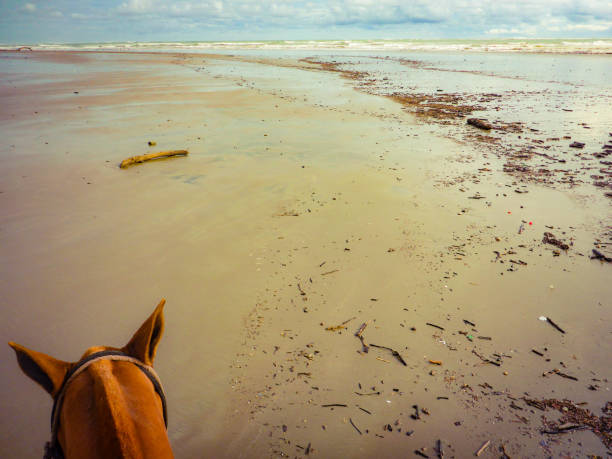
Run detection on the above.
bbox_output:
[43,350,168,459]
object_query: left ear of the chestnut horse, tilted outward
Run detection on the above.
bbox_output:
[9,341,72,397]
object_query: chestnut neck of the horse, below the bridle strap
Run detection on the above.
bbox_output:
[59,360,172,459]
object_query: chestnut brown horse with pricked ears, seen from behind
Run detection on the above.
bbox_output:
[9,300,173,459]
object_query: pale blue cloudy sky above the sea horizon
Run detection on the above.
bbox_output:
[0,0,612,44]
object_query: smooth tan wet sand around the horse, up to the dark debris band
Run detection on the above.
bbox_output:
[0,52,612,458]
